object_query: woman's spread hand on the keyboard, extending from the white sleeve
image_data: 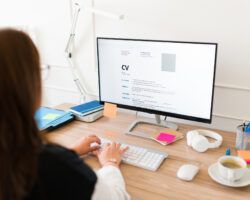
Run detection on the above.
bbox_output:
[95,142,128,167]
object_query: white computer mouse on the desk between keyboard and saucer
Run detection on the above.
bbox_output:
[177,164,199,181]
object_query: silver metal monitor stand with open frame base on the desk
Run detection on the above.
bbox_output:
[125,115,178,139]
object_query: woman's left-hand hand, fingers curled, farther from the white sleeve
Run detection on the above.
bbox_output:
[71,135,101,155]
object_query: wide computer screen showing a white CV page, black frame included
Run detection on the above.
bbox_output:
[97,37,217,123]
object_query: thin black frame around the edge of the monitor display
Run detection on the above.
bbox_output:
[96,37,218,123]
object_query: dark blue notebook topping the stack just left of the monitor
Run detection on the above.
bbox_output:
[70,100,104,116]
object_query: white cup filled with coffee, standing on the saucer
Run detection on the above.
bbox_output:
[218,156,248,182]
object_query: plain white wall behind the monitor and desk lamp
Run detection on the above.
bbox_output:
[0,0,250,130]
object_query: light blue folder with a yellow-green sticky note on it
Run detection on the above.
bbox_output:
[35,107,74,130]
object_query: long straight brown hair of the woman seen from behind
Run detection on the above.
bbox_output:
[0,29,41,200]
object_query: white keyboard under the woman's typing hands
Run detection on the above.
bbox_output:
[95,138,168,171]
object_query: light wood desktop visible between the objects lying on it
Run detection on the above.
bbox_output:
[46,105,250,200]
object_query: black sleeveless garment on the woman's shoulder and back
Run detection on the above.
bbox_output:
[26,145,97,200]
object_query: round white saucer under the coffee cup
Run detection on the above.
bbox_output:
[208,163,250,187]
